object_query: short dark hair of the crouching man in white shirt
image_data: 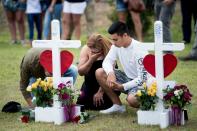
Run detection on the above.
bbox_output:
[108,21,130,36]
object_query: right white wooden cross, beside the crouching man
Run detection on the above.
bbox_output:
[139,21,184,128]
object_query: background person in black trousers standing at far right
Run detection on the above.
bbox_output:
[181,0,197,44]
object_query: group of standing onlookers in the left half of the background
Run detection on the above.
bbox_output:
[2,0,99,45]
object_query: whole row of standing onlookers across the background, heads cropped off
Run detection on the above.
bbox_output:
[2,0,197,49]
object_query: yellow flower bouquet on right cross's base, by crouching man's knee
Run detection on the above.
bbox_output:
[136,82,158,110]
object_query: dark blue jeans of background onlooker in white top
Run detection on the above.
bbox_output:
[27,13,42,40]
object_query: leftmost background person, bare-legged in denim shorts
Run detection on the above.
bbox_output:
[2,0,26,44]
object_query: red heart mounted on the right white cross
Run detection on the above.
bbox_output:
[143,54,177,78]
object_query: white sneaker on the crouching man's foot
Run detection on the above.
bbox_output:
[100,104,126,114]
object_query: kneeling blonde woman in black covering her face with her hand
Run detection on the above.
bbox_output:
[77,34,120,110]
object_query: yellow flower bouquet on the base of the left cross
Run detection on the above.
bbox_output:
[26,77,53,107]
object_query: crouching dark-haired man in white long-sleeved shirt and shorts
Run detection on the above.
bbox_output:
[96,22,148,114]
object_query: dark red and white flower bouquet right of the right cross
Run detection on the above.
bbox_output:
[163,85,192,109]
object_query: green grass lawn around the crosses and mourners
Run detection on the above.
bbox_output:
[0,2,197,131]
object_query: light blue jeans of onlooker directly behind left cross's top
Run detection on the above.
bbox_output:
[43,4,62,39]
